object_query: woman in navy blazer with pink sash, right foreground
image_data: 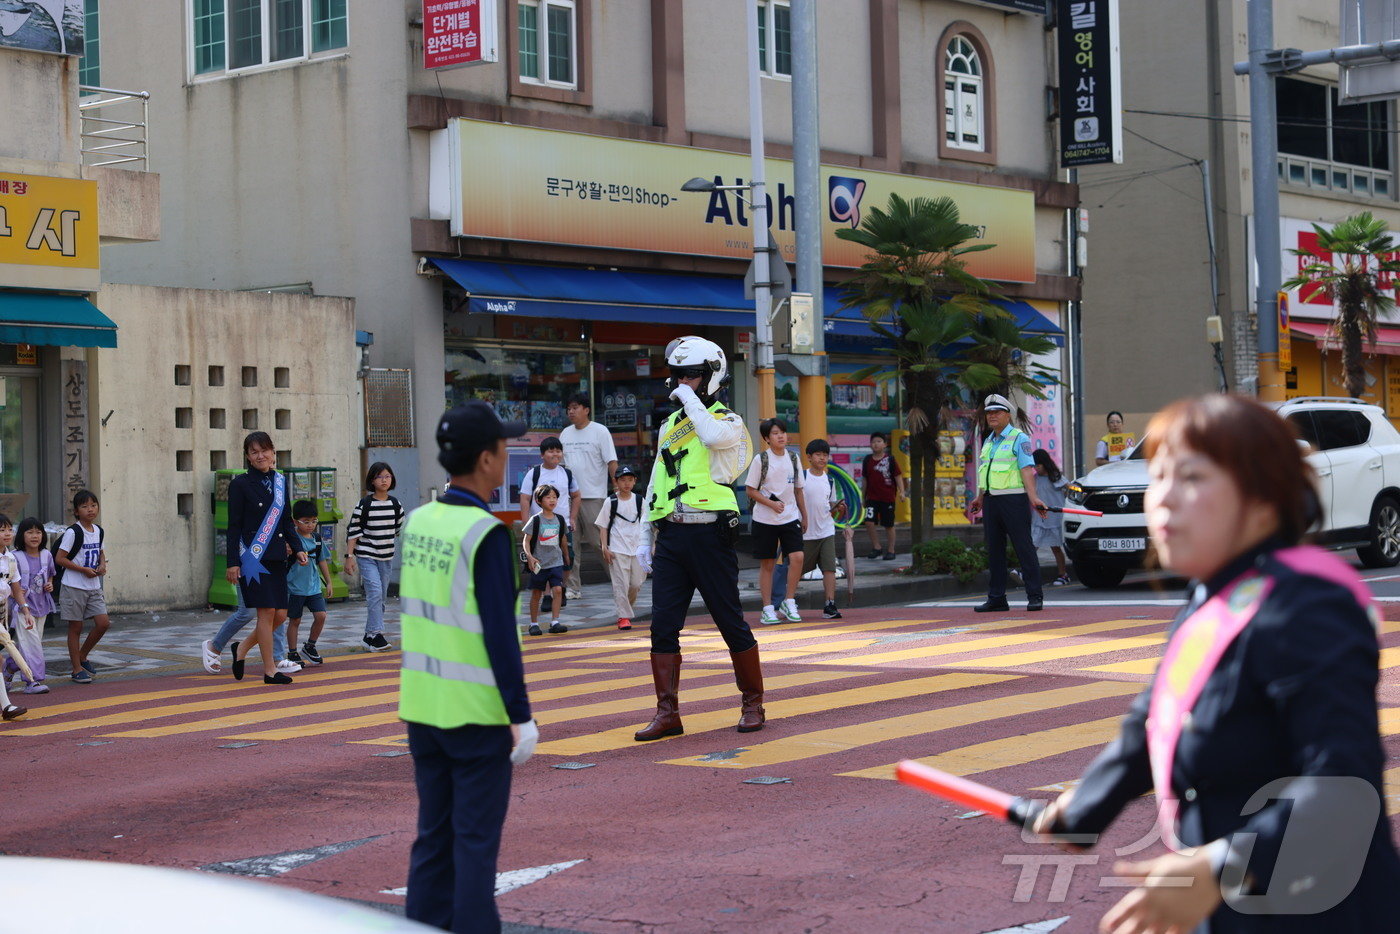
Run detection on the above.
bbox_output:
[1036,395,1400,934]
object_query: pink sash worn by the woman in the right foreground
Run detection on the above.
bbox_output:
[1147,545,1379,849]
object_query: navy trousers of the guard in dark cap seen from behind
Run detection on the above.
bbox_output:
[405,723,511,934]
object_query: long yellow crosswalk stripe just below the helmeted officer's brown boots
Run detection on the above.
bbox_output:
[665,681,1142,769]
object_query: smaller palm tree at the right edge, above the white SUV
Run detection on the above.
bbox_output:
[1284,211,1400,399]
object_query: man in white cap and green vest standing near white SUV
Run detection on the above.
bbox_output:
[967,392,1046,613]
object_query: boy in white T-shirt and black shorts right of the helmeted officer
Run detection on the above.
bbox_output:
[743,419,806,626]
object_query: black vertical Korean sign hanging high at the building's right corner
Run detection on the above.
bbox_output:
[1056,0,1123,168]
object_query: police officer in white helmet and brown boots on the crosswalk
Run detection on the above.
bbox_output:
[636,337,764,741]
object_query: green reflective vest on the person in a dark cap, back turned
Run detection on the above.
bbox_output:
[399,503,519,730]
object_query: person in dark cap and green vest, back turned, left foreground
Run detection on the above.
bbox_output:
[399,402,539,931]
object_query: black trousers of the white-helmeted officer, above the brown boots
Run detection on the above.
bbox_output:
[651,520,757,654]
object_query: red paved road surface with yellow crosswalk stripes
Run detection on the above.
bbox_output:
[0,606,1400,933]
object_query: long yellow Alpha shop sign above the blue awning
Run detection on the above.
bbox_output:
[430,118,1036,281]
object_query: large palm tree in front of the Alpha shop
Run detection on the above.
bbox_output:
[836,195,1049,543]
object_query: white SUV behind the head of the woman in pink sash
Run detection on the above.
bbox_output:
[1064,396,1400,587]
